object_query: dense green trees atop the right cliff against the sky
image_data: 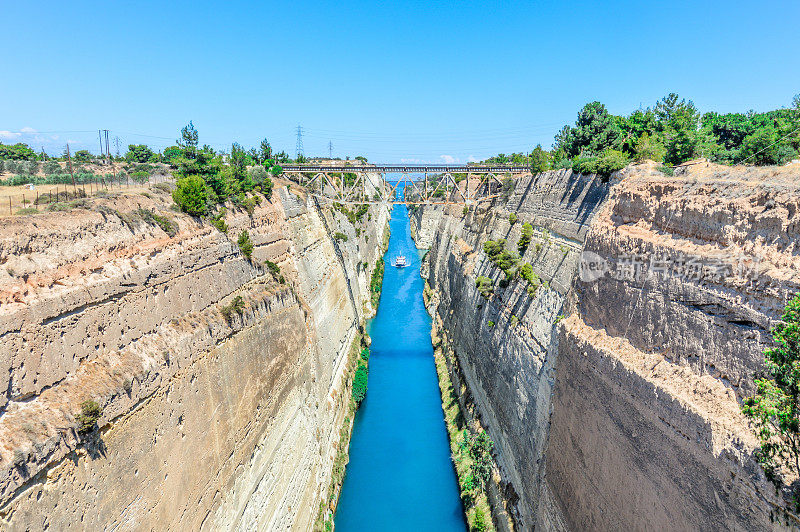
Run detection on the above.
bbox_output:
[485,93,800,175]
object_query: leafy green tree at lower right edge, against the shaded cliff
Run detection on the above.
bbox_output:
[742,295,800,510]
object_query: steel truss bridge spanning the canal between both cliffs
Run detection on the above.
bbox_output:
[282,164,530,205]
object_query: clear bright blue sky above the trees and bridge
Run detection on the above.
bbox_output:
[0,0,800,162]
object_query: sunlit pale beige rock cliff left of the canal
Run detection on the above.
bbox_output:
[0,181,388,530]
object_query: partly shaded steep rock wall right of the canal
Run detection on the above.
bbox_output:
[412,163,800,530]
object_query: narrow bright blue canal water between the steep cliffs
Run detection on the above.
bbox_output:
[336,205,466,532]
